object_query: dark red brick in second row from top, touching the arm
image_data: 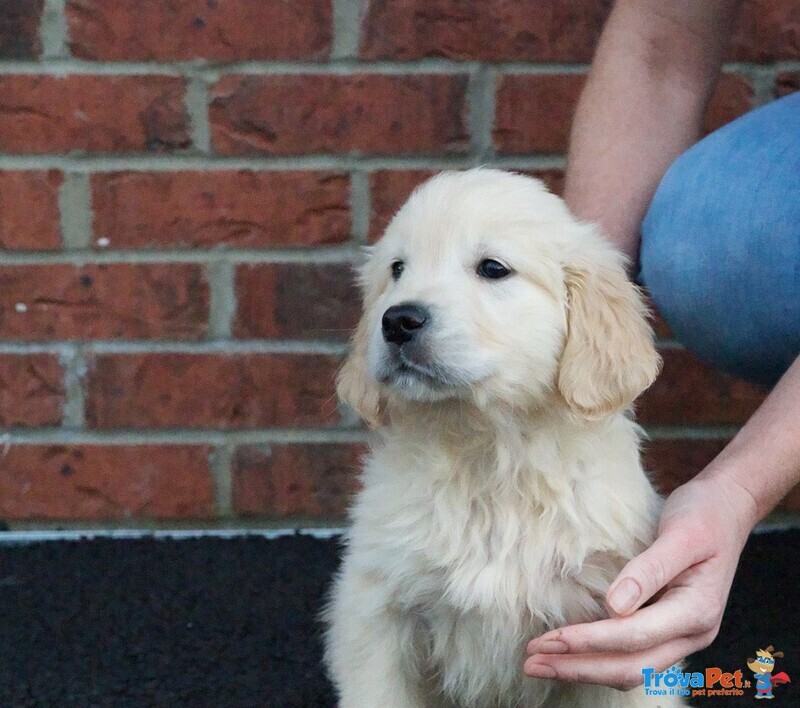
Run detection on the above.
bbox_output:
[492,74,585,154]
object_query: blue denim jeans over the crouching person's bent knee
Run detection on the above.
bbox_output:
[639,93,800,386]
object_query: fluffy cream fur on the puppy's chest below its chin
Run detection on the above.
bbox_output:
[345,415,659,705]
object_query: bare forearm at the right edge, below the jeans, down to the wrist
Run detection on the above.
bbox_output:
[697,357,800,531]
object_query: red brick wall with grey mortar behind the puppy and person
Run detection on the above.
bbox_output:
[0,0,800,525]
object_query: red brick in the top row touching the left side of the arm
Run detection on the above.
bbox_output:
[361,0,611,62]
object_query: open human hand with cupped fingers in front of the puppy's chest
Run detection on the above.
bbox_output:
[524,477,757,690]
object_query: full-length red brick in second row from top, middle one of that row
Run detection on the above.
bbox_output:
[210,74,469,155]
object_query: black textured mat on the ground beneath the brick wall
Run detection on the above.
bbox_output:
[0,531,800,708]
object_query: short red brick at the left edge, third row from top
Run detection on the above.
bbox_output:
[0,170,63,251]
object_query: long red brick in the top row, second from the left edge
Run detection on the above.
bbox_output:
[66,0,332,61]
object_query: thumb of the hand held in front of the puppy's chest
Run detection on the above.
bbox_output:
[606,526,700,615]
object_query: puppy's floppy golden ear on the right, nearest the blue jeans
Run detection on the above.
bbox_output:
[558,243,661,420]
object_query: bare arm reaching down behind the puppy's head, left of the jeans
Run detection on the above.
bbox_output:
[565,0,738,263]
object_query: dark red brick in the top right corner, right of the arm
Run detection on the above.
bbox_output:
[728,0,800,64]
